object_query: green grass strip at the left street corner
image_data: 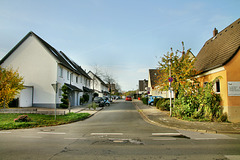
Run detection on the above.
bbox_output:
[0,113,90,130]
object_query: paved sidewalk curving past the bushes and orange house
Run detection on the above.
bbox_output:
[133,100,240,134]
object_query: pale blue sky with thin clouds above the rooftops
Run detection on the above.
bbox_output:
[0,0,240,91]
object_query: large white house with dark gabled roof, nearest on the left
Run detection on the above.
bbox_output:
[0,32,91,108]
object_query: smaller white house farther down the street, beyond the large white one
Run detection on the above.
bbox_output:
[88,71,109,97]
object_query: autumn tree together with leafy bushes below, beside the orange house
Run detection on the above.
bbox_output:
[157,43,227,121]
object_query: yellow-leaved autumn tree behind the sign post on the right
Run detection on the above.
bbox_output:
[157,42,198,98]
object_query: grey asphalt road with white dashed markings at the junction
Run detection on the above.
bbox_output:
[0,100,240,160]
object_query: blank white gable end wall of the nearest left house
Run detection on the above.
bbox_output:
[2,36,57,107]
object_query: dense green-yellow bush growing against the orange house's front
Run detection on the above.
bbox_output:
[173,77,227,121]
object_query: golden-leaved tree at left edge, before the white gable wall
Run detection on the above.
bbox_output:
[0,66,24,108]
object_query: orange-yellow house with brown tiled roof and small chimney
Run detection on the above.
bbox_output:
[195,18,240,122]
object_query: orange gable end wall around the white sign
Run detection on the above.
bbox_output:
[224,51,240,122]
